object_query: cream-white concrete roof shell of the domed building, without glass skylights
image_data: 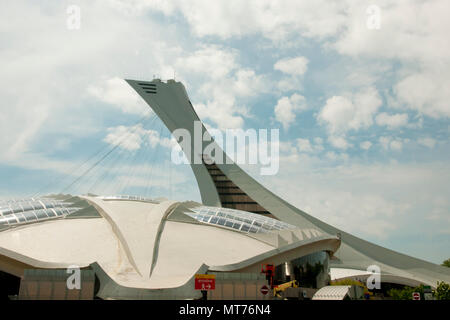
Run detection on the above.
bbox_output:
[0,196,339,298]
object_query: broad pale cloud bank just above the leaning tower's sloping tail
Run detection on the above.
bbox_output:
[256,152,450,242]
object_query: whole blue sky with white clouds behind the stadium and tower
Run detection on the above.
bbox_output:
[0,0,450,263]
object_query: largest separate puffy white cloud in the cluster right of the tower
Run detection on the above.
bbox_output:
[317,87,382,133]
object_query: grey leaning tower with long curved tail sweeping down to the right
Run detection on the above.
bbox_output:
[126,79,450,287]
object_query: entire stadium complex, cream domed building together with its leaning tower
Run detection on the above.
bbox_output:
[0,79,450,299]
